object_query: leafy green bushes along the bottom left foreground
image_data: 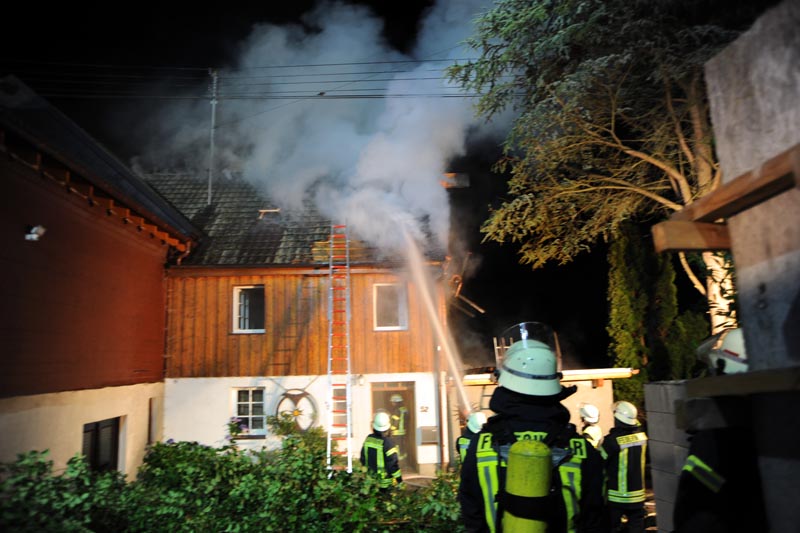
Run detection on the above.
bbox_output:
[0,418,462,533]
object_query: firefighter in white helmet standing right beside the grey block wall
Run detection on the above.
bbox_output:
[600,401,647,533]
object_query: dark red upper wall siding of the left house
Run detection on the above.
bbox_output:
[0,157,167,397]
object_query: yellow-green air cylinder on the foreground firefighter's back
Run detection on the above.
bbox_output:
[503,440,552,533]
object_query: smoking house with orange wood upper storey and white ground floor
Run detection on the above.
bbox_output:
[146,173,452,474]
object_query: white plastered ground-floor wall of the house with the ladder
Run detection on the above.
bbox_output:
[164,373,439,465]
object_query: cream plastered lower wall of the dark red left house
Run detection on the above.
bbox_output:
[0,383,164,479]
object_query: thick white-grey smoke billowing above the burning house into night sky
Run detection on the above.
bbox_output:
[138,0,500,254]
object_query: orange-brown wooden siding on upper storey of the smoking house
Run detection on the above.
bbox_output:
[167,267,441,377]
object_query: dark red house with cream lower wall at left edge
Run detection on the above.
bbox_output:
[0,76,199,475]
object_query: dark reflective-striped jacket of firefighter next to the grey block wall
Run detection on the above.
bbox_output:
[600,422,647,507]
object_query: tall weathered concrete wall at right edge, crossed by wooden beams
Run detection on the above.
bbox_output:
[705,0,800,531]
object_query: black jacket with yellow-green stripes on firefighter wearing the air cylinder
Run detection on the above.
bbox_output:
[459,387,608,533]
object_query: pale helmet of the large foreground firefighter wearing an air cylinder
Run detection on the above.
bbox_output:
[497,339,561,396]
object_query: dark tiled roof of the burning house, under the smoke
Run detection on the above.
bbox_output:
[145,172,396,266]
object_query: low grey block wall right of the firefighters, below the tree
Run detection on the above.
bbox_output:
[644,381,689,533]
